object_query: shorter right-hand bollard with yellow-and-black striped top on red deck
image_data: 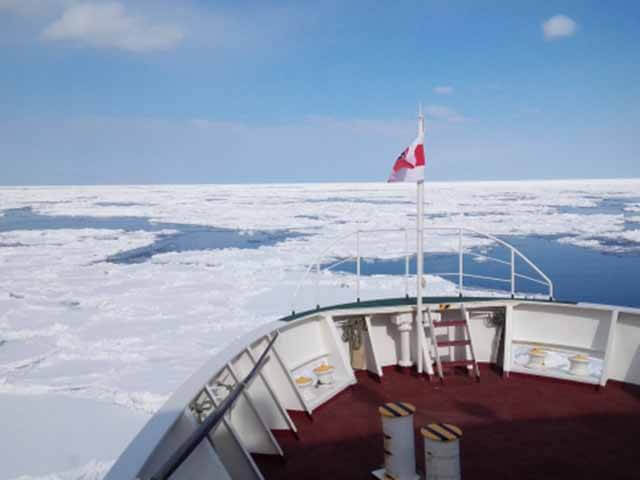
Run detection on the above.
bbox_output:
[420,423,462,480]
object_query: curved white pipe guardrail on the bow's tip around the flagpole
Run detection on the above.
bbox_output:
[291,226,553,312]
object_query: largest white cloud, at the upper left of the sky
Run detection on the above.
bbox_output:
[42,2,184,52]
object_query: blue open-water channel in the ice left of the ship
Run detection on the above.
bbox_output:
[0,207,302,263]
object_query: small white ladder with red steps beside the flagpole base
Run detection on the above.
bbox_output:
[427,303,480,382]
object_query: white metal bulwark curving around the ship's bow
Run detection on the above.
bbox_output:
[106,299,640,480]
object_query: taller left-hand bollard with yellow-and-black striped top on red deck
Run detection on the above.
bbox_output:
[372,402,420,480]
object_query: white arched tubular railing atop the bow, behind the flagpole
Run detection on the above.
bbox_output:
[291,227,553,311]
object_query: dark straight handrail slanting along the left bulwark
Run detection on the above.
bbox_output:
[151,331,278,480]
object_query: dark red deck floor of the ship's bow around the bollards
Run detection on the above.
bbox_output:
[255,365,640,480]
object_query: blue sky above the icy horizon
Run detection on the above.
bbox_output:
[0,0,640,185]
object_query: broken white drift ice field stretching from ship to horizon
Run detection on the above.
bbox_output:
[0,180,640,480]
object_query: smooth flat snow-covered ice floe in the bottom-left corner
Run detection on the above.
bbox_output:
[0,395,148,480]
